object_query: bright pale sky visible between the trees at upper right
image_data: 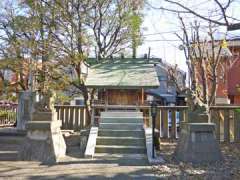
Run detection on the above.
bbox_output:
[138,0,240,71]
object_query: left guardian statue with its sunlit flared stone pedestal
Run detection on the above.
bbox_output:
[19,91,66,164]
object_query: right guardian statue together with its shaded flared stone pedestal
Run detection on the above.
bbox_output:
[175,89,222,163]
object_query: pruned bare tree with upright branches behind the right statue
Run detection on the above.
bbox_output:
[171,17,231,113]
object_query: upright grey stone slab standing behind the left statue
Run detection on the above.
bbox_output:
[17,91,36,130]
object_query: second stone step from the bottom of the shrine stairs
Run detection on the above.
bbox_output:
[95,145,146,154]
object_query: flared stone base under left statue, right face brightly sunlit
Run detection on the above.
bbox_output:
[19,120,66,164]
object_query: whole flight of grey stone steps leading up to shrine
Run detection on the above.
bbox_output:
[94,111,147,163]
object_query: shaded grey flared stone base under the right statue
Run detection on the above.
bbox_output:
[175,123,222,163]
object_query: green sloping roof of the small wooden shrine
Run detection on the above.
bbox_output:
[85,63,160,89]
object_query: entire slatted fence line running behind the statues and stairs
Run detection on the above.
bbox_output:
[0,104,236,142]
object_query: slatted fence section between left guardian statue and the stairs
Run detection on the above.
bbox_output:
[55,105,90,131]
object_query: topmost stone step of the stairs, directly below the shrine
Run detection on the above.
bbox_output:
[101,111,143,117]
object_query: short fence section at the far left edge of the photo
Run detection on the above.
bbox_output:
[0,104,17,127]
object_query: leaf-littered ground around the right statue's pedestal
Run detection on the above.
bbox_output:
[153,142,240,180]
